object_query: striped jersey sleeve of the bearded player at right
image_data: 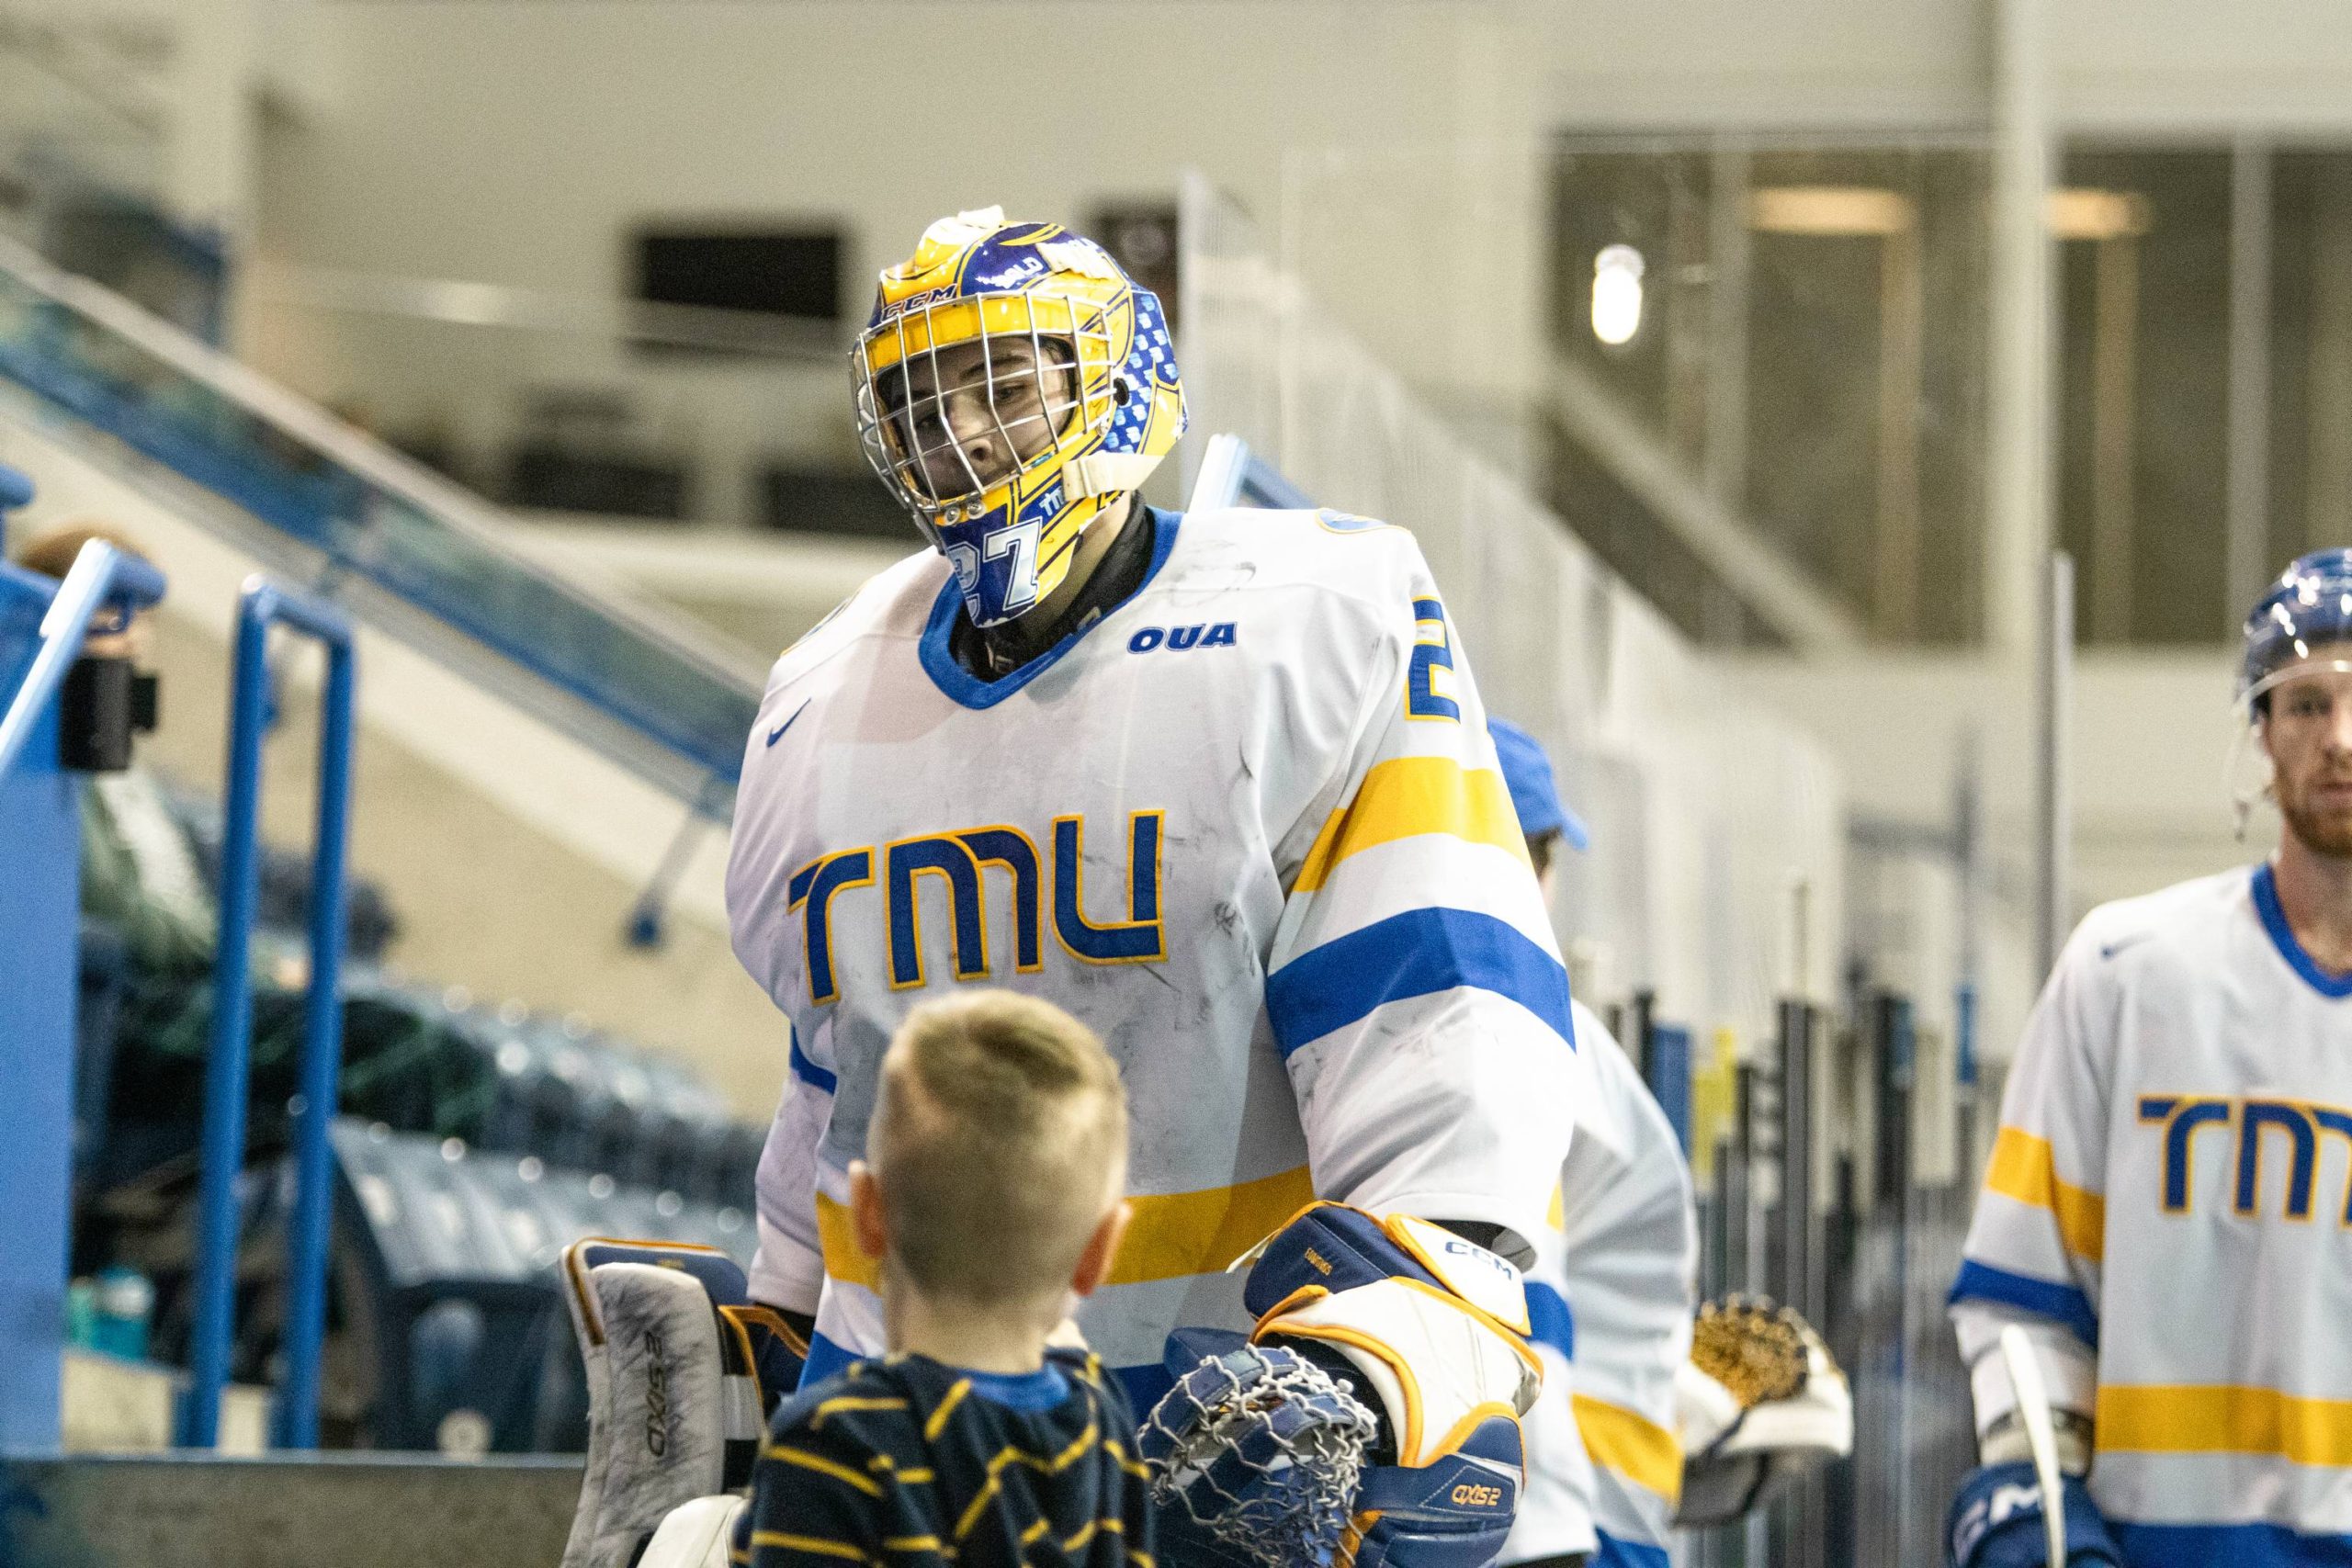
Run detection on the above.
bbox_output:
[1952,921,2112,1432]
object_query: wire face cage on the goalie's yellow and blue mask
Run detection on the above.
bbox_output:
[849,294,1120,546]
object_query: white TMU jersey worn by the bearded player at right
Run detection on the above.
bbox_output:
[1952,865,2352,1568]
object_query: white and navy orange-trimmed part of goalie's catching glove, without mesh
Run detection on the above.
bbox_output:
[1244,1203,1543,1568]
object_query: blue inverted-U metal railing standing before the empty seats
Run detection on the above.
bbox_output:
[181,579,353,1448]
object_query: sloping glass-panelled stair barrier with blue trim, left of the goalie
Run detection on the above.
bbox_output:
[0,237,760,820]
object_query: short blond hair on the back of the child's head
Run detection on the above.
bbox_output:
[865,992,1126,1307]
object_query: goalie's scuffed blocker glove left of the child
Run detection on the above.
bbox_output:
[562,1239,807,1568]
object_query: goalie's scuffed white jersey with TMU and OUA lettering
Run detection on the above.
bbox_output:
[727,510,1578,1396]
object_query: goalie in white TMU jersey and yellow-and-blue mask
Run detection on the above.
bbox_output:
[727,209,1578,1568]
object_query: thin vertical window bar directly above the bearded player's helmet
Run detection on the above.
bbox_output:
[2216,139,2269,630]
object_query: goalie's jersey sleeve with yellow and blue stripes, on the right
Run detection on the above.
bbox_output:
[1265,545,1578,1248]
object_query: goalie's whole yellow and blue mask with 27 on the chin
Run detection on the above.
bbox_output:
[849,207,1185,626]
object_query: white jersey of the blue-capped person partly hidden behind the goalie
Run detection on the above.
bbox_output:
[1500,1001,1698,1568]
